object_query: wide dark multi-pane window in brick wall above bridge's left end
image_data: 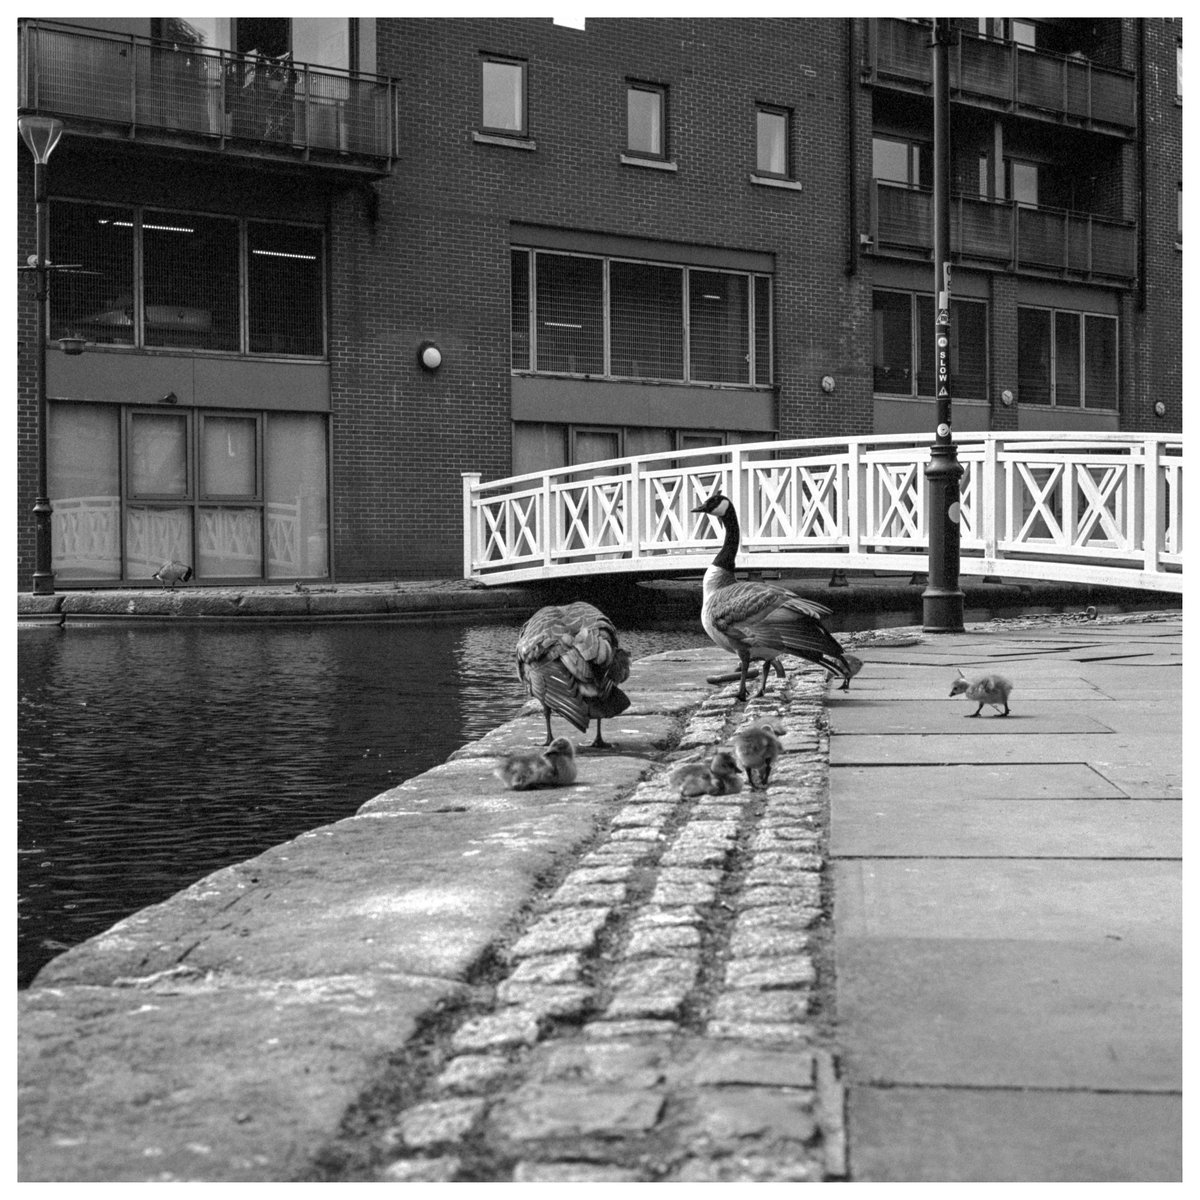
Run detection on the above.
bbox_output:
[510,248,773,388]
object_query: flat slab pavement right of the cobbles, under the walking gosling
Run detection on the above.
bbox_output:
[829,619,1183,1182]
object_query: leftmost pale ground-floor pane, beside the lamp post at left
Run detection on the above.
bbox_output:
[47,404,121,582]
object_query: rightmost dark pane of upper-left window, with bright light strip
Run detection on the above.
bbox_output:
[246,221,325,355]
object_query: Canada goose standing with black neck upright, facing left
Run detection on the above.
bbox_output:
[691,492,863,700]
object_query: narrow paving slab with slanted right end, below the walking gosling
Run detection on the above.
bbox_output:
[829,763,1126,801]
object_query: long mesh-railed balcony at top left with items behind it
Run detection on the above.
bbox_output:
[18,20,396,176]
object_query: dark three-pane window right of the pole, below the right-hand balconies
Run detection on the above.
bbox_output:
[1016,308,1118,408]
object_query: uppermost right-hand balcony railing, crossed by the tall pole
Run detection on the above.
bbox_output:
[865,17,1138,136]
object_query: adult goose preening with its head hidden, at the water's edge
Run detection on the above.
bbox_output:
[517,600,630,750]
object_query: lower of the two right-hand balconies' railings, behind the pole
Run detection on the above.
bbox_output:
[870,180,1138,286]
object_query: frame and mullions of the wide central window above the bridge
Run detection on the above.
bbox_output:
[509,245,775,391]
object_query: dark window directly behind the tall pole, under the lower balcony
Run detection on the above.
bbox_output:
[872,292,988,400]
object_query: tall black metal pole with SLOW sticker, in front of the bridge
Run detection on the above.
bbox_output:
[922,17,962,634]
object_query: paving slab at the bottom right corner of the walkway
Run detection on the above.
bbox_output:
[847,1087,1183,1183]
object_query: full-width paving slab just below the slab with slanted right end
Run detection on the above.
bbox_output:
[830,792,1183,858]
